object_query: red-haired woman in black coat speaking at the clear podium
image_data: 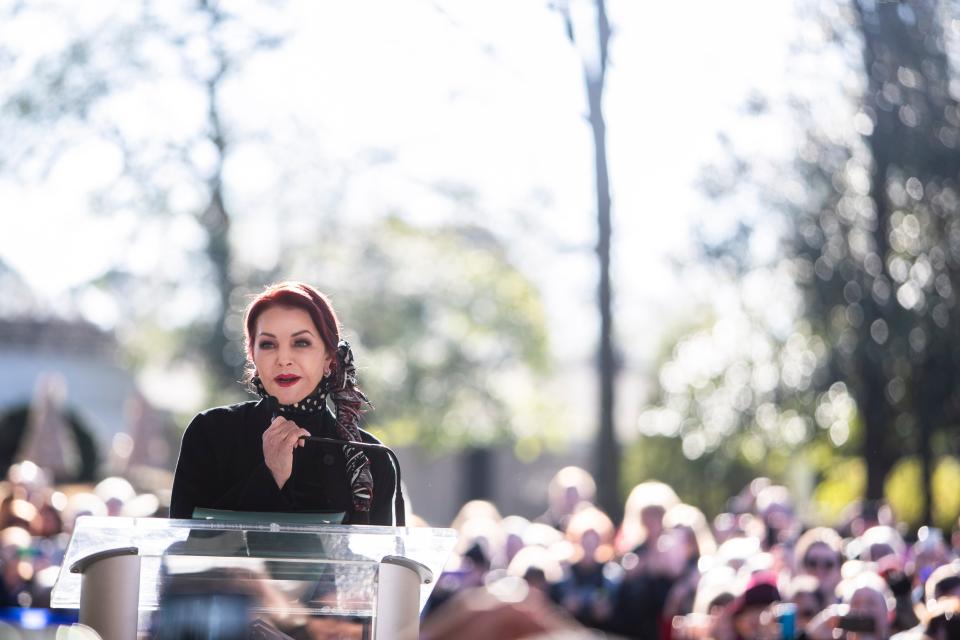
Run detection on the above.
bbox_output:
[170,282,395,525]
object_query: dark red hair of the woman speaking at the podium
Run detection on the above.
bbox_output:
[243,282,340,380]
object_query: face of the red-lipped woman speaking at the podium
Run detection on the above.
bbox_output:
[253,307,331,404]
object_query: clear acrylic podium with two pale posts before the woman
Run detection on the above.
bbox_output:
[51,516,456,640]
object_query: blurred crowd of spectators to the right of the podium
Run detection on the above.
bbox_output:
[422,467,960,640]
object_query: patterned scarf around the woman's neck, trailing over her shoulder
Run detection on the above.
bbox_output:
[252,340,373,524]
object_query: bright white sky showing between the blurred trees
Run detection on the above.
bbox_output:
[0,0,795,416]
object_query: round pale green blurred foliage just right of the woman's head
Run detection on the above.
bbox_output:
[284,217,562,456]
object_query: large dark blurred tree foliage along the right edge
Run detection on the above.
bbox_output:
[634,0,960,525]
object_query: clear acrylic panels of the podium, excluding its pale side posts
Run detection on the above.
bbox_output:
[51,516,457,617]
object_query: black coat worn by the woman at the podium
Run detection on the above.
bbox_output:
[170,400,396,525]
